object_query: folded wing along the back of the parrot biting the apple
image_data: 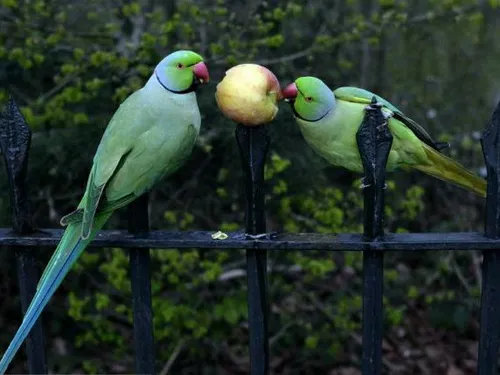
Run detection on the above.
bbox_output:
[333,86,449,151]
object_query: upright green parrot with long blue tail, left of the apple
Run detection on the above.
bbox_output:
[0,51,209,374]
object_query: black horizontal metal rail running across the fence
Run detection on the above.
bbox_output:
[0,228,500,251]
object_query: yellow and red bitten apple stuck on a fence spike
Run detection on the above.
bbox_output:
[215,64,281,126]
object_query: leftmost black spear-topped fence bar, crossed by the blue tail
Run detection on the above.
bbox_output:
[0,98,47,374]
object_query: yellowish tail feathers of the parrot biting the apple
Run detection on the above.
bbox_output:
[414,144,486,198]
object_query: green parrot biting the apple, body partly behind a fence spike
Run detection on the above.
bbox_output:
[282,77,486,197]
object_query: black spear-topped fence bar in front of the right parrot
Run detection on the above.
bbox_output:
[356,97,392,375]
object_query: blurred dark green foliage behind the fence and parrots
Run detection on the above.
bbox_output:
[0,0,500,374]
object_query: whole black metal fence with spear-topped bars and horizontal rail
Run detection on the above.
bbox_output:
[0,99,500,375]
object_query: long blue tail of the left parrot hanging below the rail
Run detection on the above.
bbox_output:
[0,212,112,375]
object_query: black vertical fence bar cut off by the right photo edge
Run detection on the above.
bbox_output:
[477,98,500,375]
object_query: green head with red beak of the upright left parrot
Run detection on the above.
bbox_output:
[155,51,209,94]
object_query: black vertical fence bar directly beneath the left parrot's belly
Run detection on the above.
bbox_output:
[128,194,155,374]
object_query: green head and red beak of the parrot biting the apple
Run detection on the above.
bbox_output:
[282,77,335,121]
